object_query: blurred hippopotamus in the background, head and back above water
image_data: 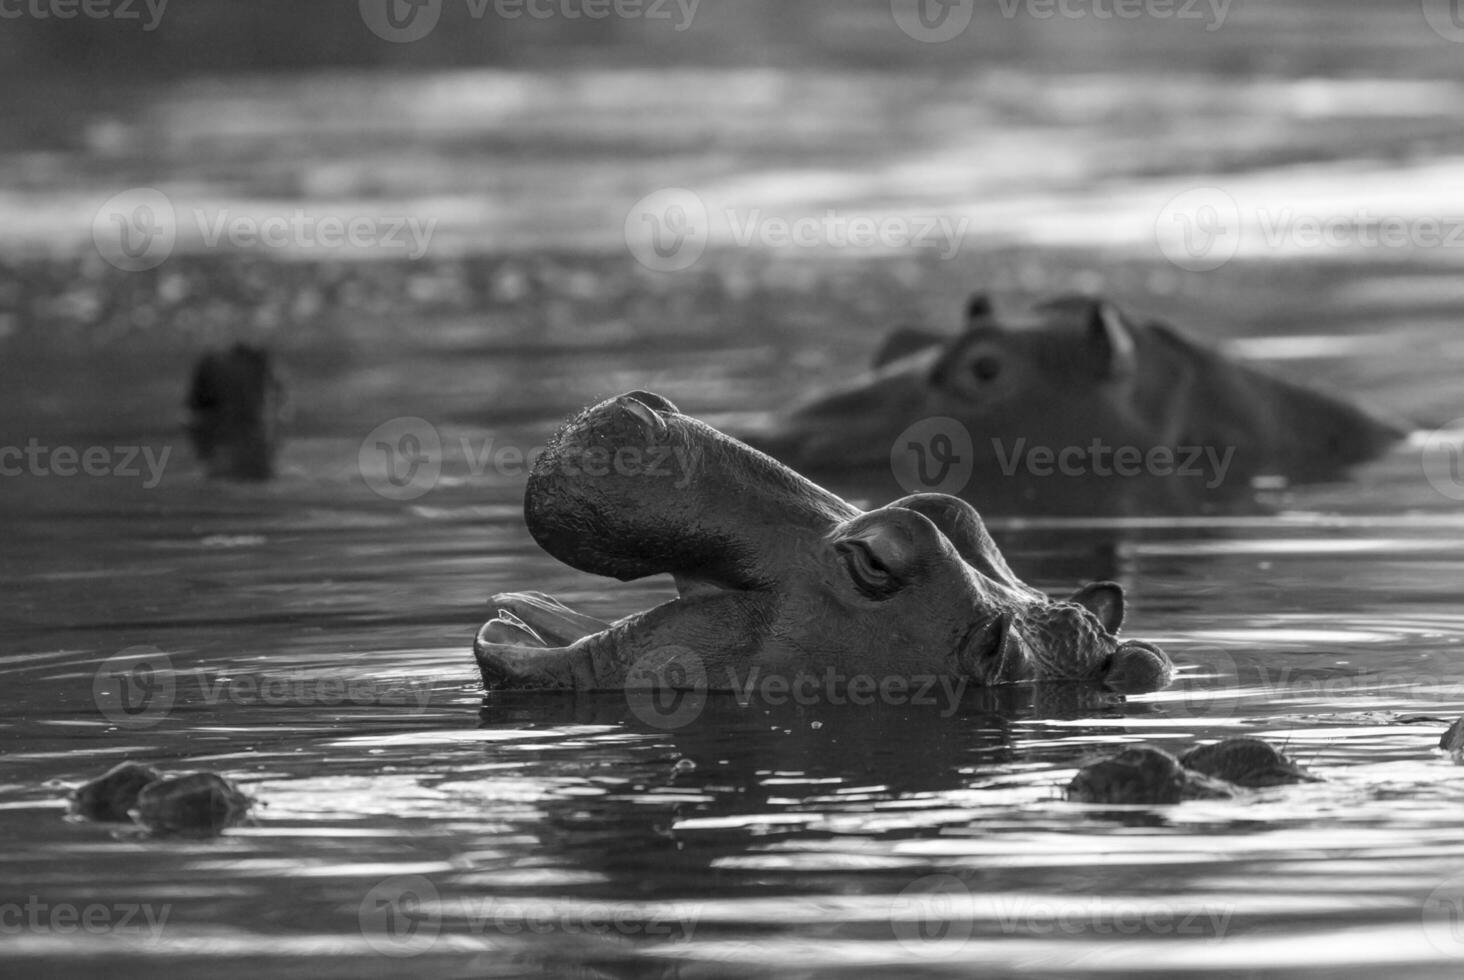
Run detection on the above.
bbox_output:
[739,293,1410,514]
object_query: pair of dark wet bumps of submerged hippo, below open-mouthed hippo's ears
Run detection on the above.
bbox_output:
[1067,737,1319,804]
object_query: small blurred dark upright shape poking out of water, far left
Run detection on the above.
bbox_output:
[184,343,284,480]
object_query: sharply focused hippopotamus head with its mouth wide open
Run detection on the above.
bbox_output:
[474,391,1173,693]
